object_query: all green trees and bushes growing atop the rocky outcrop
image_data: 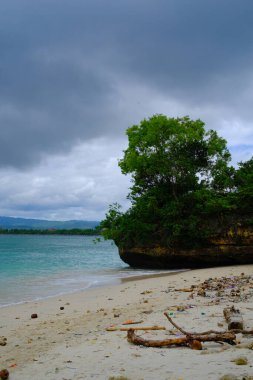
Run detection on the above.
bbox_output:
[101,115,253,248]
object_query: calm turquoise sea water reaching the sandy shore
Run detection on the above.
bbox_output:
[0,235,176,307]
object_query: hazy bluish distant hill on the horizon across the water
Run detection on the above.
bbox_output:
[0,216,99,230]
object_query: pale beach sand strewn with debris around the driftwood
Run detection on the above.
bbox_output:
[0,265,253,380]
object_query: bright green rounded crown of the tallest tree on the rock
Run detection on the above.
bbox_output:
[119,115,230,199]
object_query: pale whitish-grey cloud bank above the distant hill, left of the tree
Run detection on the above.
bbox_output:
[0,139,129,220]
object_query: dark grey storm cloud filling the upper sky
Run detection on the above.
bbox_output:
[0,0,253,167]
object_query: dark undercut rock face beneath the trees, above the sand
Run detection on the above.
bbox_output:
[119,227,253,269]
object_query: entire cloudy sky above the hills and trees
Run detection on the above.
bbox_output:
[0,0,253,220]
